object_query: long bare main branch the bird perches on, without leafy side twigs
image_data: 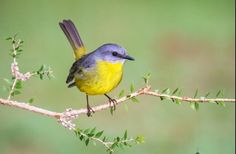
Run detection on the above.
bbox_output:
[0,86,235,119]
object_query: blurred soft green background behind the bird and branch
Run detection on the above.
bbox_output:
[0,0,235,154]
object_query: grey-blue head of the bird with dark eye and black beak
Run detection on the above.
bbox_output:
[94,43,134,63]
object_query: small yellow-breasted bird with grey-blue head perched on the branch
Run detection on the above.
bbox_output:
[59,19,134,116]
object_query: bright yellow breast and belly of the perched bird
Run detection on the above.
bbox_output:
[75,61,123,95]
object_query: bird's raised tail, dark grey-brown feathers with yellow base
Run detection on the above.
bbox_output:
[59,19,85,60]
